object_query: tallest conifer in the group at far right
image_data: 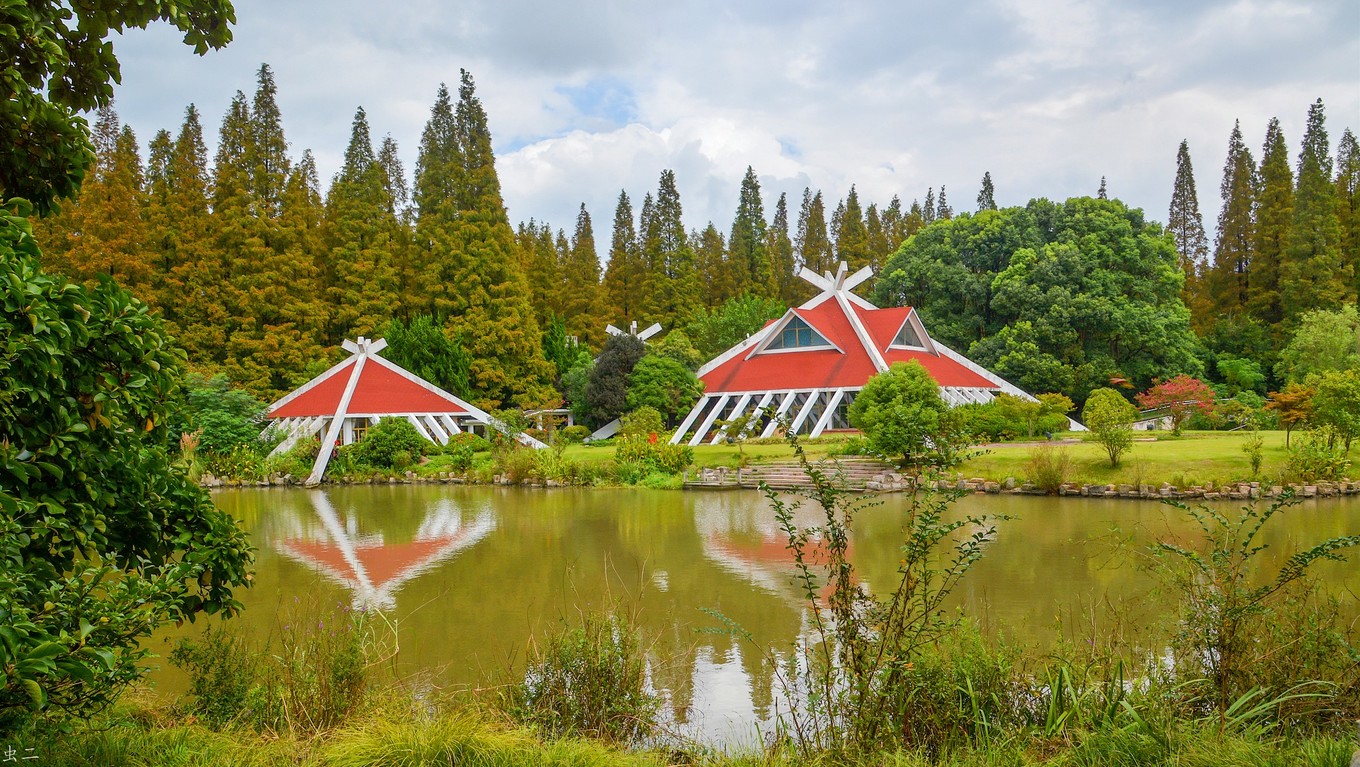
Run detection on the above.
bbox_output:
[1280,99,1355,326]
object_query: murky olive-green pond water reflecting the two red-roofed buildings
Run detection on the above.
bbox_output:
[154,484,1360,743]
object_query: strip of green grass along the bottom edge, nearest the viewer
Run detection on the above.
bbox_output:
[34,709,1355,767]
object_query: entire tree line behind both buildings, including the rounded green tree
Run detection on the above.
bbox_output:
[26,65,1360,408]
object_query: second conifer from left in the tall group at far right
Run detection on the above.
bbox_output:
[1208,122,1257,317]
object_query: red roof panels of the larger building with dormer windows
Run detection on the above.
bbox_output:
[699,301,1001,394]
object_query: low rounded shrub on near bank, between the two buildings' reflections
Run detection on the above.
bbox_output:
[503,615,660,743]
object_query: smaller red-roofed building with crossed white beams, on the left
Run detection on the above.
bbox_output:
[265,336,544,485]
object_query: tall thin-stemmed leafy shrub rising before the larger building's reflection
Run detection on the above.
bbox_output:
[762,424,1001,752]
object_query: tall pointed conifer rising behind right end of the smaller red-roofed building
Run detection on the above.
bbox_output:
[445,71,556,408]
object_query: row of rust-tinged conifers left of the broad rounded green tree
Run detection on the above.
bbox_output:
[35,65,968,407]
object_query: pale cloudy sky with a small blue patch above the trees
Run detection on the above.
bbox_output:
[114,0,1360,246]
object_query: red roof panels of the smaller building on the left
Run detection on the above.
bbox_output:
[268,355,471,417]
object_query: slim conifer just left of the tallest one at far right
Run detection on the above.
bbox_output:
[1247,117,1293,326]
